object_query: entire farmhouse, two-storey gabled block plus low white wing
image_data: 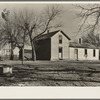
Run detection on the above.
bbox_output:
[36,30,99,60]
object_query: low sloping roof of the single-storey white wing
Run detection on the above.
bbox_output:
[69,42,99,49]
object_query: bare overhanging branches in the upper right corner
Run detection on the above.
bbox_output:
[77,4,100,34]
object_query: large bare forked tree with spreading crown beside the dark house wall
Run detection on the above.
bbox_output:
[16,5,62,61]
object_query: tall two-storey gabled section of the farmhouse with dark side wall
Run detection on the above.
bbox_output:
[36,30,70,60]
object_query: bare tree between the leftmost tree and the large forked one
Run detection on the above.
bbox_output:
[9,11,28,64]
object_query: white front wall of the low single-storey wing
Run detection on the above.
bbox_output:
[70,47,99,60]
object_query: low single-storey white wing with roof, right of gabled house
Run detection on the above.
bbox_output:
[69,42,99,60]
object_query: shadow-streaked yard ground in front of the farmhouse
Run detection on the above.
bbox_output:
[0,60,100,86]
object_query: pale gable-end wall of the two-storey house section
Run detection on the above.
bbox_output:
[51,32,69,60]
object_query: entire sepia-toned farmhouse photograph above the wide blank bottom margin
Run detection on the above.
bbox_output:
[0,2,100,87]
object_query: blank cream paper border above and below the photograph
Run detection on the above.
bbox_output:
[0,1,100,99]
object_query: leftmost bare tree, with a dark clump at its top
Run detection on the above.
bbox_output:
[1,9,15,60]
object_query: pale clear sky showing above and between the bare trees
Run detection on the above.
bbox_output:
[0,3,94,40]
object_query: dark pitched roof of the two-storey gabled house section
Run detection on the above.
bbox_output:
[36,30,70,40]
